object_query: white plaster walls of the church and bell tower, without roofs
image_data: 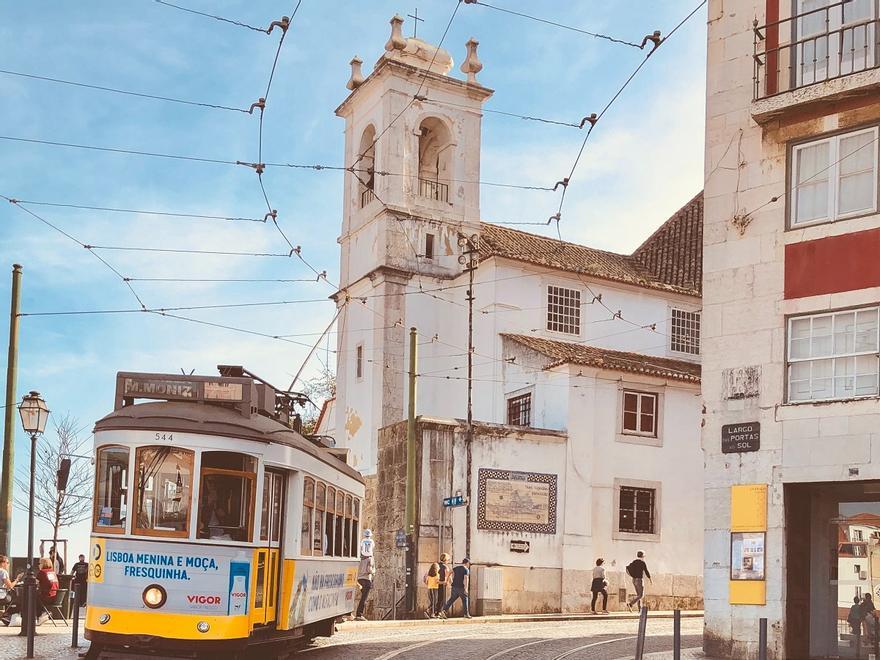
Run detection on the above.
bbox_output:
[335,14,702,611]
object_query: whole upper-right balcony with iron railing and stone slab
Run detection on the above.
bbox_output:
[752,0,880,122]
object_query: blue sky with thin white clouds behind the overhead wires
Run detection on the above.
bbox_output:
[0,0,706,554]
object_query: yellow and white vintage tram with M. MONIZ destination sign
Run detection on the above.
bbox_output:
[85,366,364,658]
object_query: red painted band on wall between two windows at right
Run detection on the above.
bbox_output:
[785,229,880,299]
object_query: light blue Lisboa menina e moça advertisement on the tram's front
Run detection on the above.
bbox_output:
[89,538,253,615]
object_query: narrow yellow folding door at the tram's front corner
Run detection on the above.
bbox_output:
[251,469,286,625]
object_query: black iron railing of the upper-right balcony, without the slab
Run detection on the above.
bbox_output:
[754,0,880,99]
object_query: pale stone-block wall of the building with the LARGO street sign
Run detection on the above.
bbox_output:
[702,0,880,658]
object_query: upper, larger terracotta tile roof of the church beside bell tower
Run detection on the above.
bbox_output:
[480,193,703,297]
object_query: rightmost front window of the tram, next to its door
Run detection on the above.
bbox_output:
[198,451,257,542]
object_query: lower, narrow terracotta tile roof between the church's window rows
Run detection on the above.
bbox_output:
[501,334,700,383]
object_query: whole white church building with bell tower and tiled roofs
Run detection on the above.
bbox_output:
[319,17,703,612]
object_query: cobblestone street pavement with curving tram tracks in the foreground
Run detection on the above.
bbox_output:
[0,618,703,660]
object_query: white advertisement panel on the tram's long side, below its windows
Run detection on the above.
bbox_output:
[288,559,357,628]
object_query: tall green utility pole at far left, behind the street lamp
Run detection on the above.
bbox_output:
[0,264,21,561]
